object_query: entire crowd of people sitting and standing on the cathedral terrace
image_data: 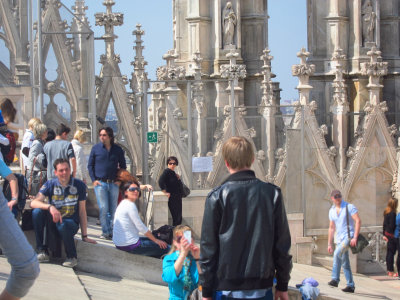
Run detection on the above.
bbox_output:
[0,95,400,300]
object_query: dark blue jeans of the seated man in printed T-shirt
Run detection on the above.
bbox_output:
[32,208,79,258]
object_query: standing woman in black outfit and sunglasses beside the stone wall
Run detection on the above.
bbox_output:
[158,156,182,226]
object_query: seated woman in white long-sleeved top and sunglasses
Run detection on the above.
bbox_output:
[113,181,169,258]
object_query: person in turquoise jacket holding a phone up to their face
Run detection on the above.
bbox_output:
[162,225,201,300]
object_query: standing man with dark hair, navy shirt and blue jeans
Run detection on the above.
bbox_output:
[88,127,126,240]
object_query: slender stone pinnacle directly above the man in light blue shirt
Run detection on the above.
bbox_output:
[331,49,349,186]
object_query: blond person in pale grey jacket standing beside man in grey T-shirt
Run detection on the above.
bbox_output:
[26,123,47,196]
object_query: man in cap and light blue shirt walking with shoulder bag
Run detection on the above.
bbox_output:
[328,190,361,293]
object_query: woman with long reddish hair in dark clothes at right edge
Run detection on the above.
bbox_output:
[383,198,400,277]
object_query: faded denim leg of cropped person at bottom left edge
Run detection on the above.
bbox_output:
[0,192,39,297]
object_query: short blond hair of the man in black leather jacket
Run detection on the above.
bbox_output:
[222,136,254,170]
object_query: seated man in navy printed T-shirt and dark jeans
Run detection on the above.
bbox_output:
[31,158,96,268]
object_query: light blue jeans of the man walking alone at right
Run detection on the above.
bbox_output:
[332,239,354,287]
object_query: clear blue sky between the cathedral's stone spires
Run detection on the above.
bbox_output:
[82,0,307,100]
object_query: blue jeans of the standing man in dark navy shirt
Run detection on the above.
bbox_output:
[94,181,119,236]
